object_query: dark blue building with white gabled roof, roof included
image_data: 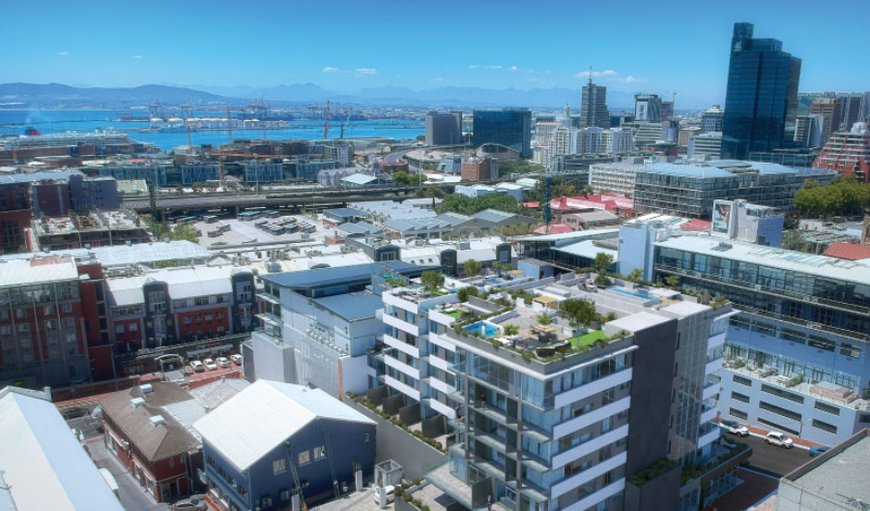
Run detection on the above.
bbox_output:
[194,380,376,511]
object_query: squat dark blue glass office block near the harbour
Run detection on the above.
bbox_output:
[472,108,532,158]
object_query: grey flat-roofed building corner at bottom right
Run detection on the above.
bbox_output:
[776,429,870,511]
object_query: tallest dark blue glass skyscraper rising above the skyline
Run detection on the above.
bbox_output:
[722,23,801,159]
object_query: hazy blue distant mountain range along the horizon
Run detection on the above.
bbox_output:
[0,83,634,111]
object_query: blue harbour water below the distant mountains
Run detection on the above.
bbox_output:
[0,109,425,151]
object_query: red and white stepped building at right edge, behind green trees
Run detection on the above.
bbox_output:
[813,123,870,183]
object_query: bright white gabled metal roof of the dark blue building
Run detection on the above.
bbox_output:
[194,380,375,470]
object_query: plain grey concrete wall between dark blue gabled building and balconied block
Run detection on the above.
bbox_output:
[345,399,447,479]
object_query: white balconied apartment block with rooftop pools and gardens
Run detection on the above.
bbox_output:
[375,274,747,510]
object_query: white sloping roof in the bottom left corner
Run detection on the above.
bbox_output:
[0,387,124,511]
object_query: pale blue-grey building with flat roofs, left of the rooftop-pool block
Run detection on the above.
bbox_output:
[245,264,427,399]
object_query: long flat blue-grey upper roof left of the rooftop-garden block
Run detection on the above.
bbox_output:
[263,261,427,288]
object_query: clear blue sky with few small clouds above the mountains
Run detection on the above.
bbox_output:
[0,0,870,107]
